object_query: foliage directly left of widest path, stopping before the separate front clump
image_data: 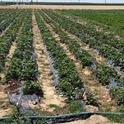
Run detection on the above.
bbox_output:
[6,12,38,80]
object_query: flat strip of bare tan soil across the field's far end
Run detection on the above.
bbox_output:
[0,5,124,10]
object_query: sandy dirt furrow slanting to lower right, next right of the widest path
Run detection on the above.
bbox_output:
[42,17,116,111]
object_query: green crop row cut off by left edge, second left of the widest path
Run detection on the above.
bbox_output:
[0,10,24,71]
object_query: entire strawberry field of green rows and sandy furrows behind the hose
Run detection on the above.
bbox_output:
[0,9,124,122]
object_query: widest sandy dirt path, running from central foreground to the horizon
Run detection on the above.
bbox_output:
[32,15,65,112]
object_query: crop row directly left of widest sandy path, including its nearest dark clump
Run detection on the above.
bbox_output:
[6,11,43,95]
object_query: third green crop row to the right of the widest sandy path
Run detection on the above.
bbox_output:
[45,10,124,71]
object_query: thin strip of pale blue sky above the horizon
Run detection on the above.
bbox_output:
[2,0,124,3]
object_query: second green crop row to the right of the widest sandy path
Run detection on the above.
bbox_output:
[41,12,124,104]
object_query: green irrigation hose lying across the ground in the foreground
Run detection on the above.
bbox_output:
[0,112,124,121]
